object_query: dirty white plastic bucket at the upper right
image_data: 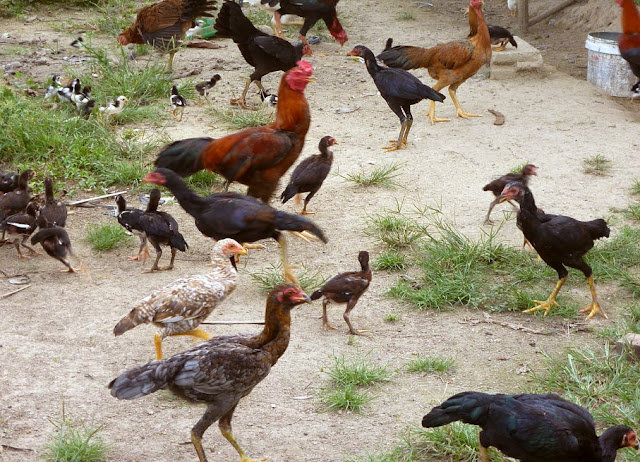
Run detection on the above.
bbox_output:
[584,32,638,98]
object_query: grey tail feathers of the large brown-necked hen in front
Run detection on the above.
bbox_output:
[109,360,182,399]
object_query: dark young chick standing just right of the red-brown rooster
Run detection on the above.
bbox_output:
[280,136,338,215]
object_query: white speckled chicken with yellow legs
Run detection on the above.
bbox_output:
[113,239,247,359]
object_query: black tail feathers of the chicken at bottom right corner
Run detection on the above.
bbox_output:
[422,391,495,428]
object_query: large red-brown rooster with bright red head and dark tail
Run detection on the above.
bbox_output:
[156,61,313,203]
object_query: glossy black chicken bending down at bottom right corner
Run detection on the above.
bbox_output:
[422,391,638,462]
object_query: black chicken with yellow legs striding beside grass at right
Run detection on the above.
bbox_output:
[499,182,609,319]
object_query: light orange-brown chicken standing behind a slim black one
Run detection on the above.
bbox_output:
[378,0,491,124]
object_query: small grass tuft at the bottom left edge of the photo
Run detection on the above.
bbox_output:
[44,406,108,462]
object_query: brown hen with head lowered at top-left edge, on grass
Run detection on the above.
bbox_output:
[118,0,216,72]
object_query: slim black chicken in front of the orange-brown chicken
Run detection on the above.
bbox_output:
[349,45,445,151]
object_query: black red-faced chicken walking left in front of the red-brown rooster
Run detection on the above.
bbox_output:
[144,168,327,282]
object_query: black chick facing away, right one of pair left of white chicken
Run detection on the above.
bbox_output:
[140,188,189,272]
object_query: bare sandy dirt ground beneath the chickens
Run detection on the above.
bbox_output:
[0,0,640,462]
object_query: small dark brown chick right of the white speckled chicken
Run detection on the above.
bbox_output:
[311,250,372,335]
